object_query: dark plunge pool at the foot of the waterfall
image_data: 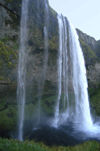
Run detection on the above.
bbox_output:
[29,123,100,146]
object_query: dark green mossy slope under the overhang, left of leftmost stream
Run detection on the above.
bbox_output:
[0,86,17,137]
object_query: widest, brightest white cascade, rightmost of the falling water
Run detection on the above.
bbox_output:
[68,19,93,129]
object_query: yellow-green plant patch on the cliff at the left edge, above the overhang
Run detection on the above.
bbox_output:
[0,39,17,80]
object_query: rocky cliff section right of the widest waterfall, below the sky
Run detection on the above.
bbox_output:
[77,29,100,87]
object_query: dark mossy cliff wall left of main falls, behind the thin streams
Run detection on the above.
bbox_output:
[0,0,58,137]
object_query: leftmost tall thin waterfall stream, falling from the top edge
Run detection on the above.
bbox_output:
[17,0,29,141]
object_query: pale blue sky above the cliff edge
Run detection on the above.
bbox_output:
[49,0,100,40]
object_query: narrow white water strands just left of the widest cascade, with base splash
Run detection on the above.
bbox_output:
[53,15,70,127]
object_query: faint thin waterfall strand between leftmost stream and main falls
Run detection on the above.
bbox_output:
[38,0,49,124]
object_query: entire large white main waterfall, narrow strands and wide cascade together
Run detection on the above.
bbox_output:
[52,15,98,132]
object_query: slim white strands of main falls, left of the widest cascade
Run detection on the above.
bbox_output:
[53,16,68,127]
